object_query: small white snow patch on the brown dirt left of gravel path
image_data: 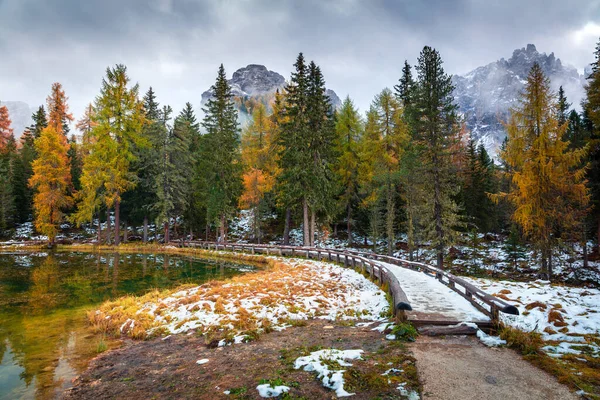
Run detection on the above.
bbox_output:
[294,349,363,397]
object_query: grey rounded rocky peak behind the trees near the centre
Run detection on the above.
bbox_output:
[202,64,342,124]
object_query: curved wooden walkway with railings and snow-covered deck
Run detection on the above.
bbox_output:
[185,241,519,329]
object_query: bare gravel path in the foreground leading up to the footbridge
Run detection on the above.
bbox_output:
[410,336,579,400]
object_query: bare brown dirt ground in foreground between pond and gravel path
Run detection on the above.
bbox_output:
[64,320,419,400]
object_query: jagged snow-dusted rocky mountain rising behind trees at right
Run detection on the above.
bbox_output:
[452,44,585,157]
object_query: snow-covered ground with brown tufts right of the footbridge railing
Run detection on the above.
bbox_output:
[464,278,600,357]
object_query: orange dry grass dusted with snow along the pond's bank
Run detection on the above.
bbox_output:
[88,251,384,343]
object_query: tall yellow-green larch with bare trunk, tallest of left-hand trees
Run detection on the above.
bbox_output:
[73,64,148,245]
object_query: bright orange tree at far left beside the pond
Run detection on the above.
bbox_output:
[29,124,72,246]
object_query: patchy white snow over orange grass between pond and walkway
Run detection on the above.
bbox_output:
[109,257,389,345]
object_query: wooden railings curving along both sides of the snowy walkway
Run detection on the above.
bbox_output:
[178,241,519,321]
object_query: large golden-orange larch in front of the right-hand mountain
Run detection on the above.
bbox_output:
[495,63,589,279]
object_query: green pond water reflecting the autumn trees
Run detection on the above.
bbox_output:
[0,252,252,400]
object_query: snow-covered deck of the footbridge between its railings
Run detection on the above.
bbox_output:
[382,263,489,322]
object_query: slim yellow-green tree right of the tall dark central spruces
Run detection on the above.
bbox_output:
[335,97,363,246]
